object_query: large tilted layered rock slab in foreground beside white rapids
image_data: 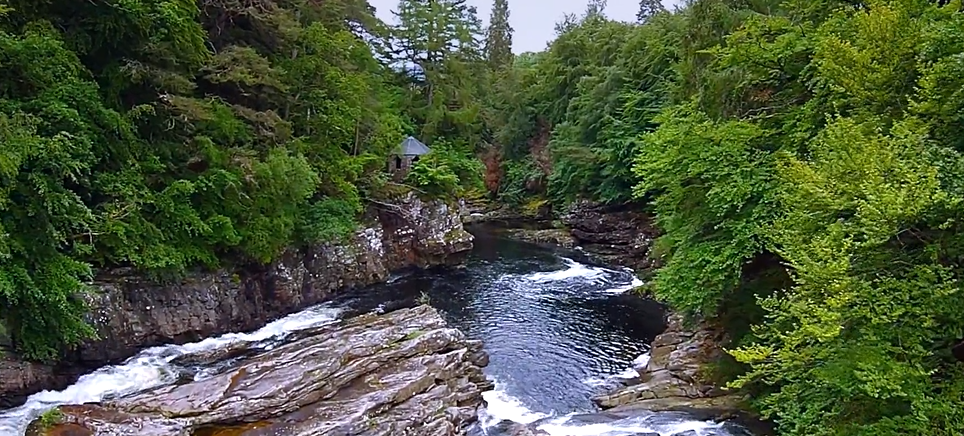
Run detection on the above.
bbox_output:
[27,306,493,436]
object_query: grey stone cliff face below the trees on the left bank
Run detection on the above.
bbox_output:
[0,195,473,407]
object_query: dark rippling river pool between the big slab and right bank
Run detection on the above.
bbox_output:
[332,231,663,413]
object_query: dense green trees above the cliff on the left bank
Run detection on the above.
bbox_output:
[0,0,458,360]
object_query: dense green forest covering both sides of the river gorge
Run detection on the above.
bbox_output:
[0,0,964,436]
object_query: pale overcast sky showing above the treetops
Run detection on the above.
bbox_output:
[368,0,681,53]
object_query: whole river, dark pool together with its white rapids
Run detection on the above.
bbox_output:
[0,227,739,436]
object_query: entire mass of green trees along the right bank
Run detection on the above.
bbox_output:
[492,0,964,436]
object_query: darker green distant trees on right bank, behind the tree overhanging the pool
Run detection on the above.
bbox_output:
[496,8,678,205]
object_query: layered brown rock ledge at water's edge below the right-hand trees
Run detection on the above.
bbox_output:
[593,314,744,418]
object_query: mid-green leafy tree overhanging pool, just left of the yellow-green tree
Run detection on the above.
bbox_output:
[634,106,774,314]
